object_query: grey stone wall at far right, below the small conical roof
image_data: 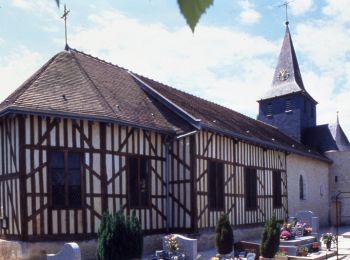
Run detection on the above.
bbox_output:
[325,151,350,225]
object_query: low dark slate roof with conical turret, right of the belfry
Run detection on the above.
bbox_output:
[302,122,350,153]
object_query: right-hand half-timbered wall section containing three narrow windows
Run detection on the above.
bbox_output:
[195,131,288,229]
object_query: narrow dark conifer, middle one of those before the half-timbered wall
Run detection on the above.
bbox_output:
[215,214,233,254]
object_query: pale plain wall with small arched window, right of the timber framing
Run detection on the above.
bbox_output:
[287,154,330,226]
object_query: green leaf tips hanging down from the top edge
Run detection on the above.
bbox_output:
[55,0,214,32]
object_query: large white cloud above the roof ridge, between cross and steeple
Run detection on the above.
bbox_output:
[71,11,279,117]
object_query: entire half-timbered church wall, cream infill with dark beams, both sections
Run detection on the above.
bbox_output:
[0,115,287,241]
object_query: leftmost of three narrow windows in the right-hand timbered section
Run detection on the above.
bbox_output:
[208,161,225,210]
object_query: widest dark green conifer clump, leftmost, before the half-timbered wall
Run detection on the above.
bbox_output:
[96,211,143,260]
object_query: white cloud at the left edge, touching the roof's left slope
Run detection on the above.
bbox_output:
[0,46,45,101]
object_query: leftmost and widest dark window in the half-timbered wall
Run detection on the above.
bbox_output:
[49,151,82,208]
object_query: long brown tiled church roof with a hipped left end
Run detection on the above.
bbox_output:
[0,46,329,162]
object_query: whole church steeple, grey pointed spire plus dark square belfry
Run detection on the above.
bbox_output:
[258,21,317,141]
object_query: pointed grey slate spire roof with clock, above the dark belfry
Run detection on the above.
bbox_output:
[262,22,317,103]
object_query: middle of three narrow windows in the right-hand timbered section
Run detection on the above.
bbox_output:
[244,168,258,210]
